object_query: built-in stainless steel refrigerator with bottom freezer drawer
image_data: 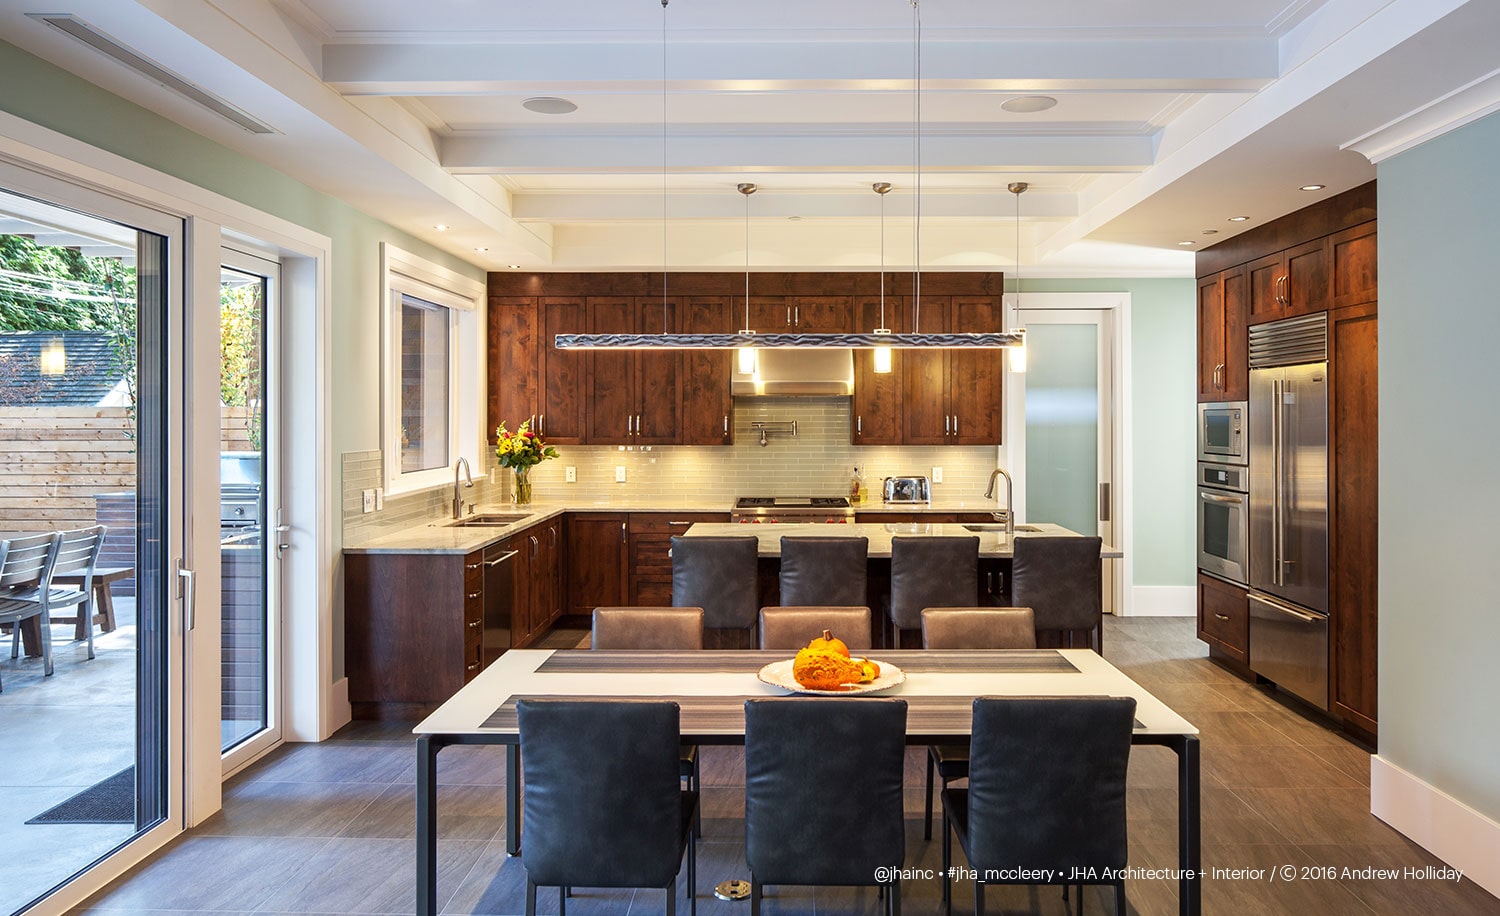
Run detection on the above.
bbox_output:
[1250,315,1329,709]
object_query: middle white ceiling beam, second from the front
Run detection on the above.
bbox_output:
[438,130,1155,180]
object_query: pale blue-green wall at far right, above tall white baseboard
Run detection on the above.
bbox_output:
[1377,115,1500,820]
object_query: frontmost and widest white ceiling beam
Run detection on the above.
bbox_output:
[323,37,1278,96]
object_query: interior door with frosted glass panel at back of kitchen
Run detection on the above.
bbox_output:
[1011,309,1118,613]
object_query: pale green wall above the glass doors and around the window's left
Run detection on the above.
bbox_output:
[0,42,485,454]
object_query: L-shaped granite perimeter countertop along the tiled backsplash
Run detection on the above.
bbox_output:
[344,495,1014,556]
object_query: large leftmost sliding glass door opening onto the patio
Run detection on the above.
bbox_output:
[0,162,194,913]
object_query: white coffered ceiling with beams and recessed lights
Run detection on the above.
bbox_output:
[0,0,1500,277]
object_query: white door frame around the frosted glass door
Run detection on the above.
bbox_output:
[1001,292,1134,616]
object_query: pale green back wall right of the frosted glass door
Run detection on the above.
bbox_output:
[1023,277,1199,590]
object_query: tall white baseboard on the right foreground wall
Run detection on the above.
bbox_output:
[1370,754,1500,897]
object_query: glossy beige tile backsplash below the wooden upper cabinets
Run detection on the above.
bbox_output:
[344,397,998,544]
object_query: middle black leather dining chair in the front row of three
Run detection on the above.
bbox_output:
[746,697,906,916]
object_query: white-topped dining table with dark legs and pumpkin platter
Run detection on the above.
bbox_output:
[413,649,1202,916]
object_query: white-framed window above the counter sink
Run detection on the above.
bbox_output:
[381,244,483,493]
